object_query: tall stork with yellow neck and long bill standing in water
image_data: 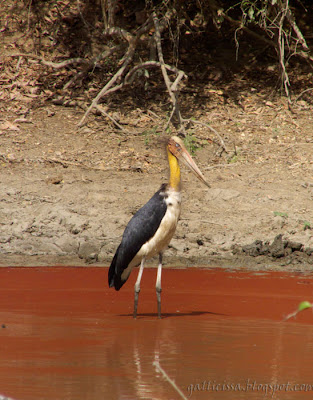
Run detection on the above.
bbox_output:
[109,136,209,318]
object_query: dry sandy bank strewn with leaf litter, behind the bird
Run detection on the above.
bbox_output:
[0,95,313,269]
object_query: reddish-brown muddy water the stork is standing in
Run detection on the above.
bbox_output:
[0,267,313,400]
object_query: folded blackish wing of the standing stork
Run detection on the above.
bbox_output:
[109,185,167,290]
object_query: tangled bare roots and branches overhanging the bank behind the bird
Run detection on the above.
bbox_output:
[3,0,313,148]
